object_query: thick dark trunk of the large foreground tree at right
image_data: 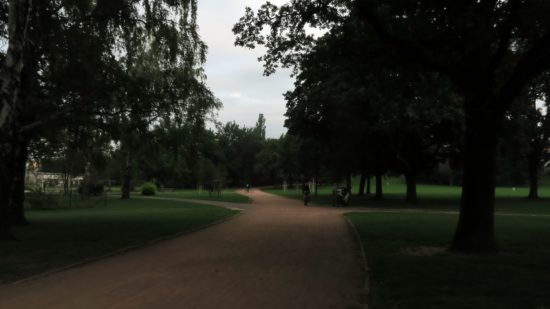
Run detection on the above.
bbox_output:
[451,99,498,253]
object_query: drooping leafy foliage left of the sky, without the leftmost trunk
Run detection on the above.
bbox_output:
[2,0,221,209]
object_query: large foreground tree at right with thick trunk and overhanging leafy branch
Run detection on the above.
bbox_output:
[234,0,550,252]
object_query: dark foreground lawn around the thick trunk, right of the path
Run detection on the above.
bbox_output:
[347,213,550,309]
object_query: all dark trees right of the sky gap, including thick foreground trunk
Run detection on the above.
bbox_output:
[233,0,550,252]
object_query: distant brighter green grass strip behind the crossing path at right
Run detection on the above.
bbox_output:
[265,181,550,214]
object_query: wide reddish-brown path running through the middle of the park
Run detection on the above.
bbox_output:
[0,190,363,309]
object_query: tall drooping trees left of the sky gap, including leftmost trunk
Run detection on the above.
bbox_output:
[0,0,215,240]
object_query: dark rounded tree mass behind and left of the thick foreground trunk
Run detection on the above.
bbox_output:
[286,18,461,203]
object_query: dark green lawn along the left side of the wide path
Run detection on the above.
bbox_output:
[0,198,236,284]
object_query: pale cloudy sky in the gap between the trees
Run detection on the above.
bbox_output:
[198,0,294,138]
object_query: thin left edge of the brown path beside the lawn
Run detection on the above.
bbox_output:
[0,206,244,289]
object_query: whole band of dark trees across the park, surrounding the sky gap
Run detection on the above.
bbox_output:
[0,0,550,252]
